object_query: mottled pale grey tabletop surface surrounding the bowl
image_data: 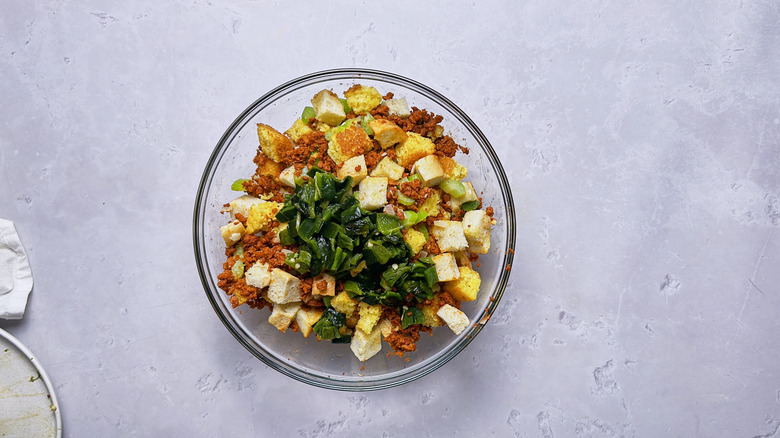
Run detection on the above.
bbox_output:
[0,0,780,437]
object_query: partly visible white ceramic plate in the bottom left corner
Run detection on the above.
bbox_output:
[0,329,62,438]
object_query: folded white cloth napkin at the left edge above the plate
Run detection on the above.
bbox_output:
[0,219,32,319]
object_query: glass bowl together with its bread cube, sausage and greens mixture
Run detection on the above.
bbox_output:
[193,69,515,391]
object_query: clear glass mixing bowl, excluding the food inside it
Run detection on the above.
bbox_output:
[193,69,515,391]
